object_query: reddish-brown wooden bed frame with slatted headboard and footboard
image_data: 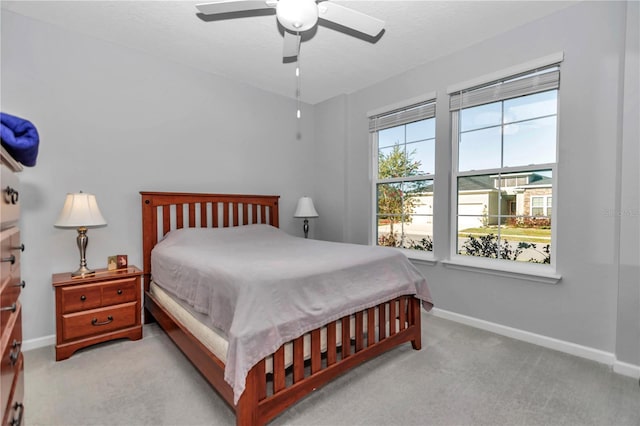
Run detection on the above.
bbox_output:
[140,192,421,426]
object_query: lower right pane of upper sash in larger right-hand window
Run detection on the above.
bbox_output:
[503,117,556,167]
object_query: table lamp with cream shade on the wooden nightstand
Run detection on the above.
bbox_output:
[53,191,107,277]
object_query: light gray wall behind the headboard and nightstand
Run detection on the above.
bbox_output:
[1,10,314,340]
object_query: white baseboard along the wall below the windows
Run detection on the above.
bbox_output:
[431,308,640,378]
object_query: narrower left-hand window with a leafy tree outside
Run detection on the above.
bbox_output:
[369,100,435,251]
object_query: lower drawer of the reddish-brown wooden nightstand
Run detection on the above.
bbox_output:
[62,302,137,341]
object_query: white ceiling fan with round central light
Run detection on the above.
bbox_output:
[196,0,384,59]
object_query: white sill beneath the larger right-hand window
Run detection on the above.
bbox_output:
[442,256,562,284]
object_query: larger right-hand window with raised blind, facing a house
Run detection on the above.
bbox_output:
[450,65,560,263]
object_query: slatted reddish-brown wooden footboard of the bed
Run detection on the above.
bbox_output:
[236,296,421,425]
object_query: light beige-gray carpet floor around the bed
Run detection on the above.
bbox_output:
[25,313,640,426]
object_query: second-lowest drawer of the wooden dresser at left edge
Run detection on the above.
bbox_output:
[0,304,22,420]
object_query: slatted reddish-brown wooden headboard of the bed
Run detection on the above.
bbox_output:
[140,191,280,290]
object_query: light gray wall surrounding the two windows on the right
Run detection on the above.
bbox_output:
[316,2,640,366]
